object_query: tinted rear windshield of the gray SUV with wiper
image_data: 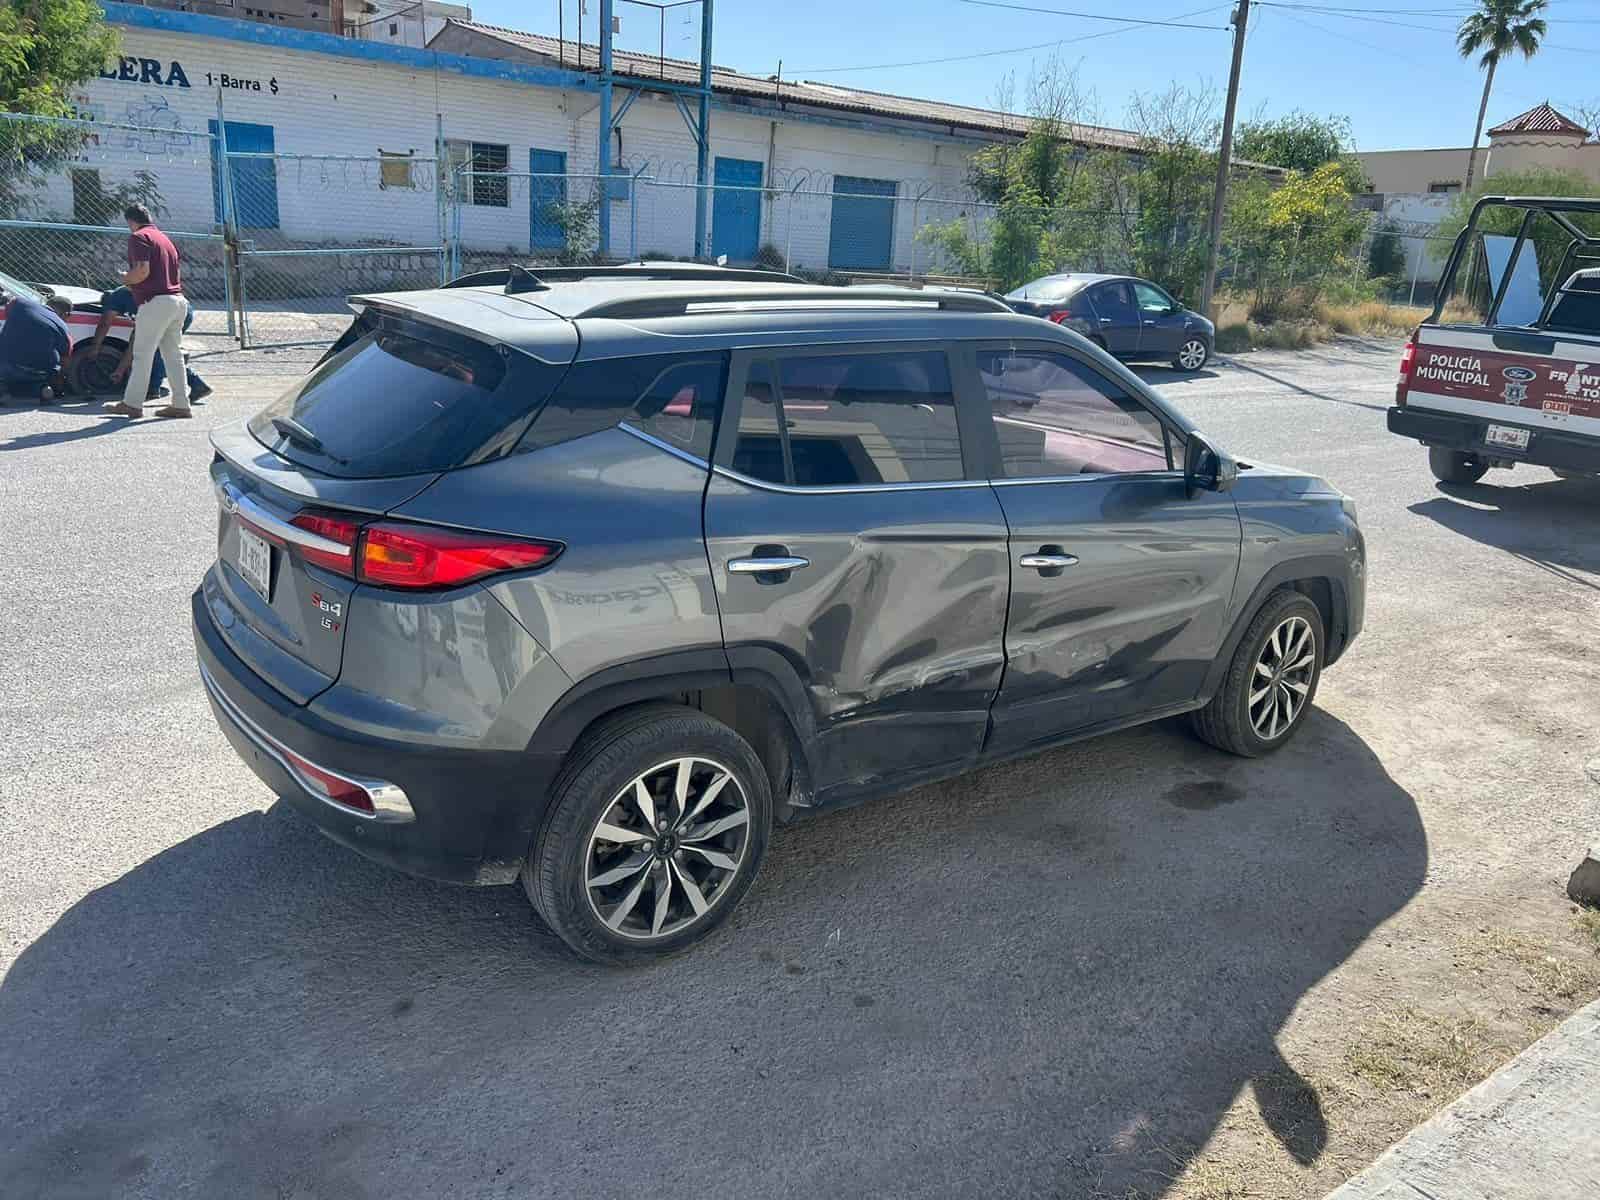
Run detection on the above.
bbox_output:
[250,312,565,478]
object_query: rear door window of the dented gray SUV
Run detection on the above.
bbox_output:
[733,350,962,488]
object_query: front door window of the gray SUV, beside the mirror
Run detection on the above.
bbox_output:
[978,350,1168,478]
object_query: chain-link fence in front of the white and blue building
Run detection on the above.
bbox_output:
[0,101,1472,361]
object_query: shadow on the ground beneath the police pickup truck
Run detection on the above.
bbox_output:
[1410,470,1600,592]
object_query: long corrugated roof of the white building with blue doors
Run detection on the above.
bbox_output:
[434,18,1139,149]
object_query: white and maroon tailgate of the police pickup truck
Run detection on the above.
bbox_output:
[1405,325,1600,438]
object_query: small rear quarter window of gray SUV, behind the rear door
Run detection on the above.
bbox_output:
[517,355,725,461]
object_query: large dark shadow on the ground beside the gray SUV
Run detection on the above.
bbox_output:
[0,712,1427,1200]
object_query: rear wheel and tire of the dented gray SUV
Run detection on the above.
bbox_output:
[522,706,773,965]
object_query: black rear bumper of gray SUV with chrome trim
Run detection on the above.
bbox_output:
[190,590,550,883]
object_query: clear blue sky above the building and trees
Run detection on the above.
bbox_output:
[469,0,1600,150]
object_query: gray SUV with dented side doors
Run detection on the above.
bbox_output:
[194,269,1365,963]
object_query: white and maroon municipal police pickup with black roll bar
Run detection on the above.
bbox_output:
[1389,195,1600,483]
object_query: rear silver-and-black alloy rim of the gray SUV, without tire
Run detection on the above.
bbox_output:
[584,757,750,941]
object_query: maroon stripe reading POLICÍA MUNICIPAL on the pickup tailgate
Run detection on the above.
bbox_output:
[1411,346,1600,418]
